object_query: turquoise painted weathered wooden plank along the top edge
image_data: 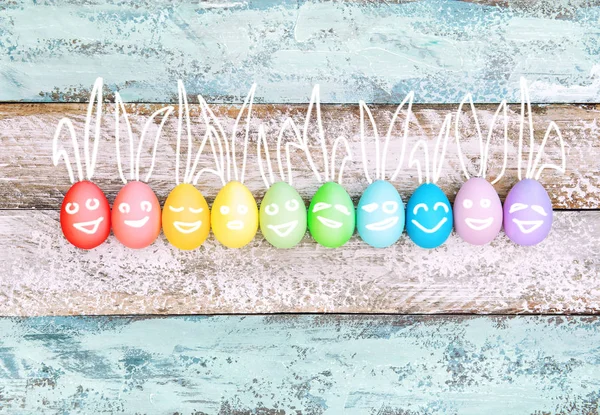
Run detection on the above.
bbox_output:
[0,0,600,103]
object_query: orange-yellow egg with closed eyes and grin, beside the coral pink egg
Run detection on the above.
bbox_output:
[162,183,210,250]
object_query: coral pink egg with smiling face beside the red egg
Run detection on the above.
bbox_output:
[112,182,161,249]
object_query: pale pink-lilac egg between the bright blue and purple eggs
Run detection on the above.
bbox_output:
[454,177,502,245]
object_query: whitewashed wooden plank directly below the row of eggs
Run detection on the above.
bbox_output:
[0,210,600,316]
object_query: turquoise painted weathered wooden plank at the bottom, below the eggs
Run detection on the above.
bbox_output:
[0,316,600,415]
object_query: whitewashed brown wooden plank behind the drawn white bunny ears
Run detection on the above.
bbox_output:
[0,102,600,209]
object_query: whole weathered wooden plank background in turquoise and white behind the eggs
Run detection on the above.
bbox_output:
[0,0,600,415]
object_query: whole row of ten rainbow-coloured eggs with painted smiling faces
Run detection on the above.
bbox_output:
[60,178,552,250]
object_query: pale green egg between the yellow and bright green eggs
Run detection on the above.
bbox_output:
[260,182,306,248]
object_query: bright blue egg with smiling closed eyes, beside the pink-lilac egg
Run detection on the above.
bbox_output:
[406,183,452,248]
